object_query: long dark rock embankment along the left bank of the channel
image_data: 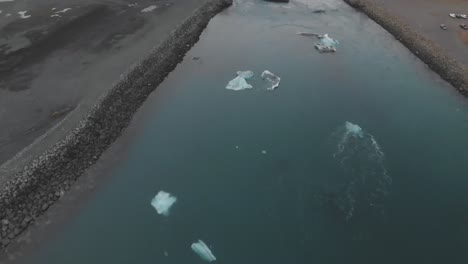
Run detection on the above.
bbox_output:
[0,0,232,248]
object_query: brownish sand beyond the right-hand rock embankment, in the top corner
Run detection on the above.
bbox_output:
[374,0,468,65]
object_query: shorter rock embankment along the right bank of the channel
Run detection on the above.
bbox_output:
[344,0,468,96]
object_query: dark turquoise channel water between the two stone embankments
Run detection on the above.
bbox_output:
[25,0,468,264]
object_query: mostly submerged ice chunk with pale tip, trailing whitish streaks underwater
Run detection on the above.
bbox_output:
[333,122,392,220]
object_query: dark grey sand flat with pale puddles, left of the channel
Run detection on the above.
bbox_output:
[0,0,203,165]
